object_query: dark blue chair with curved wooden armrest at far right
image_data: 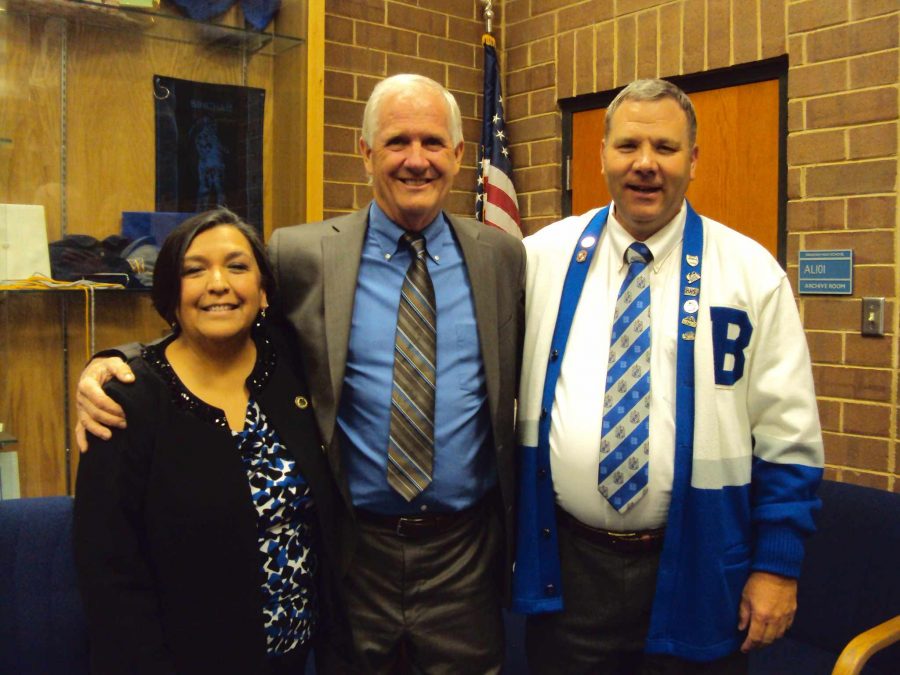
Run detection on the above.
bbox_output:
[750,481,900,675]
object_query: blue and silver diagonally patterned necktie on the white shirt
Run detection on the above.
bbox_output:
[598,242,653,513]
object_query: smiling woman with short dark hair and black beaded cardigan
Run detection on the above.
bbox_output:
[75,209,350,675]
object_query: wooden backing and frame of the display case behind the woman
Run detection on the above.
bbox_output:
[0,0,324,498]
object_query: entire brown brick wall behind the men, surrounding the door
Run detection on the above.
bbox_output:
[325,0,900,492]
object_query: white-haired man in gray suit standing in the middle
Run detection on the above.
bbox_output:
[78,75,525,673]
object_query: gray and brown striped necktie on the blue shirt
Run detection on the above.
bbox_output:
[387,232,437,501]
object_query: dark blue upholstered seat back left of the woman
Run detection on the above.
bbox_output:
[0,497,88,675]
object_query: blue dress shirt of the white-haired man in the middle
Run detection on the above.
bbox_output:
[337,202,497,515]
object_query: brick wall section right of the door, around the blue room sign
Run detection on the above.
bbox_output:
[786,0,900,492]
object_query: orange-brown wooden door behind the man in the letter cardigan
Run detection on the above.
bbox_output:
[571,80,783,262]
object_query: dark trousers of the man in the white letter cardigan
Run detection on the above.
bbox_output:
[525,512,747,675]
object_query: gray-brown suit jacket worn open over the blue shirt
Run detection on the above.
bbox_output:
[269,207,525,592]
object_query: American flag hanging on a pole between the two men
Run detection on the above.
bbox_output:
[475,35,522,239]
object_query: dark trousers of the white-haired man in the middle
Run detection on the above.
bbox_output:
[326,499,504,675]
